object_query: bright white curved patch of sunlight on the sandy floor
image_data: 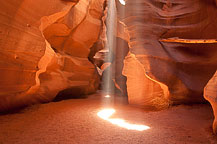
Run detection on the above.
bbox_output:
[97,109,150,131]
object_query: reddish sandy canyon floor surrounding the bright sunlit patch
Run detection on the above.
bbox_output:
[0,92,217,144]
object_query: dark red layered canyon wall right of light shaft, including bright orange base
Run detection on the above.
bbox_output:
[117,0,217,108]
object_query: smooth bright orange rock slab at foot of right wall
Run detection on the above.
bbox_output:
[123,53,169,109]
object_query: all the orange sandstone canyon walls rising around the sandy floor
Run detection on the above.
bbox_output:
[0,0,217,132]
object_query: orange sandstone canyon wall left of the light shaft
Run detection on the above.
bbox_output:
[0,0,104,111]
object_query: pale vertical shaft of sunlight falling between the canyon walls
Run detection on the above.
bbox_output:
[101,0,117,98]
